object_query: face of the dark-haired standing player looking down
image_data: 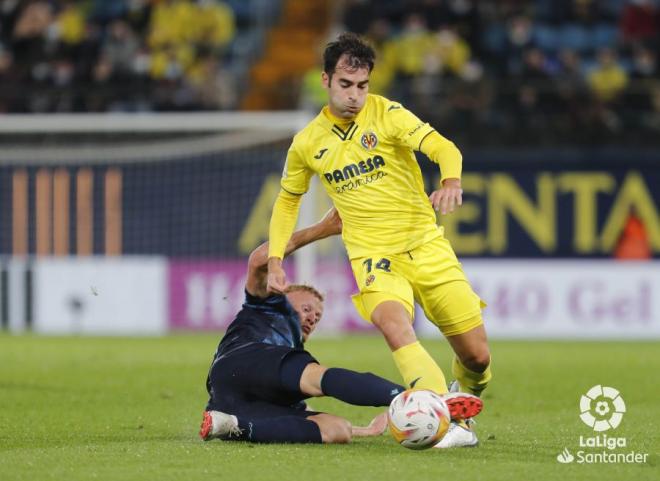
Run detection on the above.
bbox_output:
[321,55,369,120]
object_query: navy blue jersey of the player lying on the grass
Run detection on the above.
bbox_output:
[215,291,303,359]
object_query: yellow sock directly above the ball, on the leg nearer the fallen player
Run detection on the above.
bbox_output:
[392,341,447,394]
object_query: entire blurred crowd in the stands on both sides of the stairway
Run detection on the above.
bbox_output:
[0,0,660,145]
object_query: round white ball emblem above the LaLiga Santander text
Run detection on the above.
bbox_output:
[580,384,626,432]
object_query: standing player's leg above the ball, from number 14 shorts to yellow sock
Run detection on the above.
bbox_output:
[351,254,447,394]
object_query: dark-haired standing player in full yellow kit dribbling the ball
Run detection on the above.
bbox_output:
[268,33,491,447]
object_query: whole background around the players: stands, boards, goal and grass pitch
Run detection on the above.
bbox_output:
[0,0,660,481]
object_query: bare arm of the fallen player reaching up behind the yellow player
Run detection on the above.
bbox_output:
[245,207,342,297]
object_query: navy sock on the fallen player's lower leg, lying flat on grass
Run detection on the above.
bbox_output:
[231,416,321,443]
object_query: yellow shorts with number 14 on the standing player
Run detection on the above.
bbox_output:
[351,237,486,336]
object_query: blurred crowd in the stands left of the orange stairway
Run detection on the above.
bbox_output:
[0,0,237,112]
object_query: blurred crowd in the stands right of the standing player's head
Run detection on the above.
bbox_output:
[332,0,660,144]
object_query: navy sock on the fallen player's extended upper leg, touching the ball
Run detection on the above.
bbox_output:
[321,367,405,406]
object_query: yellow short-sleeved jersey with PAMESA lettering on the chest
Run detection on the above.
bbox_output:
[281,95,453,259]
